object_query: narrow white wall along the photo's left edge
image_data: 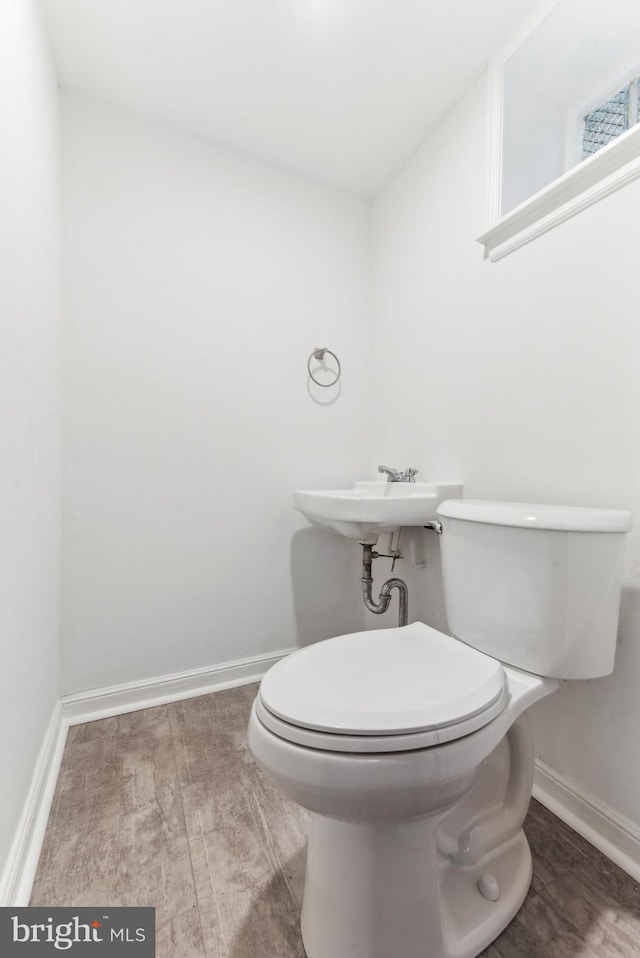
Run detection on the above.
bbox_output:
[0,0,60,872]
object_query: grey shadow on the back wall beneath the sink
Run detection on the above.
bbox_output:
[291,527,365,647]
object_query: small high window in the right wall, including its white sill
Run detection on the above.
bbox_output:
[479,0,640,260]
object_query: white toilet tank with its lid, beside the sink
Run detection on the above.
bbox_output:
[437,499,631,679]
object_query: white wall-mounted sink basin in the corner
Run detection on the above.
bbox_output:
[293,480,462,545]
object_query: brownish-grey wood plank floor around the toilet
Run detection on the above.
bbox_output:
[31,686,640,958]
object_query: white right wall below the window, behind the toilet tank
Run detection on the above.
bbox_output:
[373,81,640,824]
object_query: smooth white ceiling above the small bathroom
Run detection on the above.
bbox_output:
[42,0,536,195]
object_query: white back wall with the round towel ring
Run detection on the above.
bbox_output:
[63,94,370,692]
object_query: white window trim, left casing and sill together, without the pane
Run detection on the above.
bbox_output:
[477,0,640,262]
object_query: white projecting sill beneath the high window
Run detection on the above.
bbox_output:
[478,124,640,262]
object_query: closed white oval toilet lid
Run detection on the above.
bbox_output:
[260,622,505,737]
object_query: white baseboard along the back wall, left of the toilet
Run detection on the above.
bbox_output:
[62,649,294,725]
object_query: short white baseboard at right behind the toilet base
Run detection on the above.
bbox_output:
[533,759,640,881]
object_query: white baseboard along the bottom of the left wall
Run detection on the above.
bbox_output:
[0,702,68,907]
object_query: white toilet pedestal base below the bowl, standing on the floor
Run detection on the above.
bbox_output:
[301,815,531,958]
